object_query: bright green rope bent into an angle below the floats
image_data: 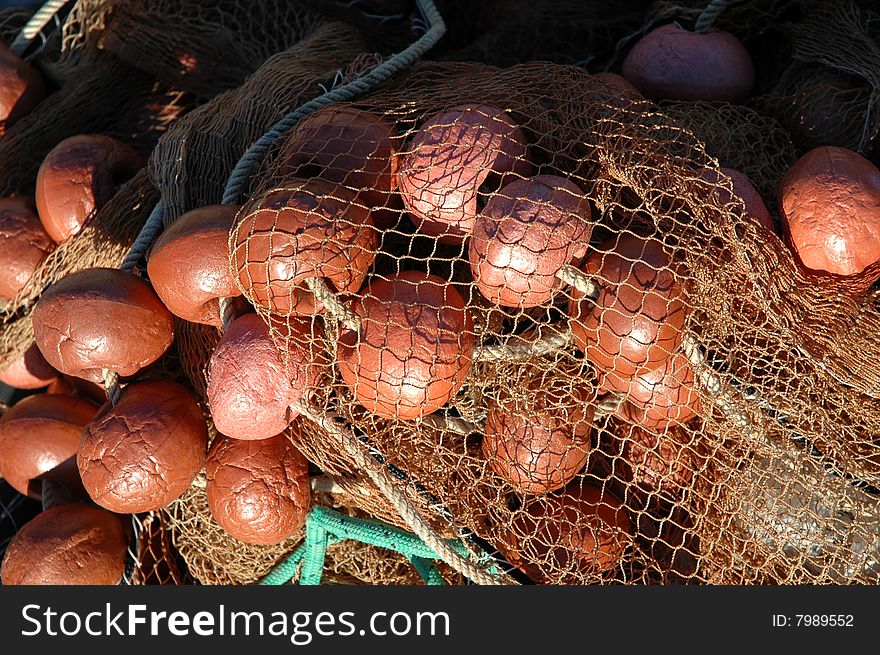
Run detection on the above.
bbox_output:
[259,506,496,585]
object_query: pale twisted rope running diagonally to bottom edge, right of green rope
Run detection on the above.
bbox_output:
[292,402,510,585]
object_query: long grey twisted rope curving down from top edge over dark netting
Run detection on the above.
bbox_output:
[222,0,446,205]
